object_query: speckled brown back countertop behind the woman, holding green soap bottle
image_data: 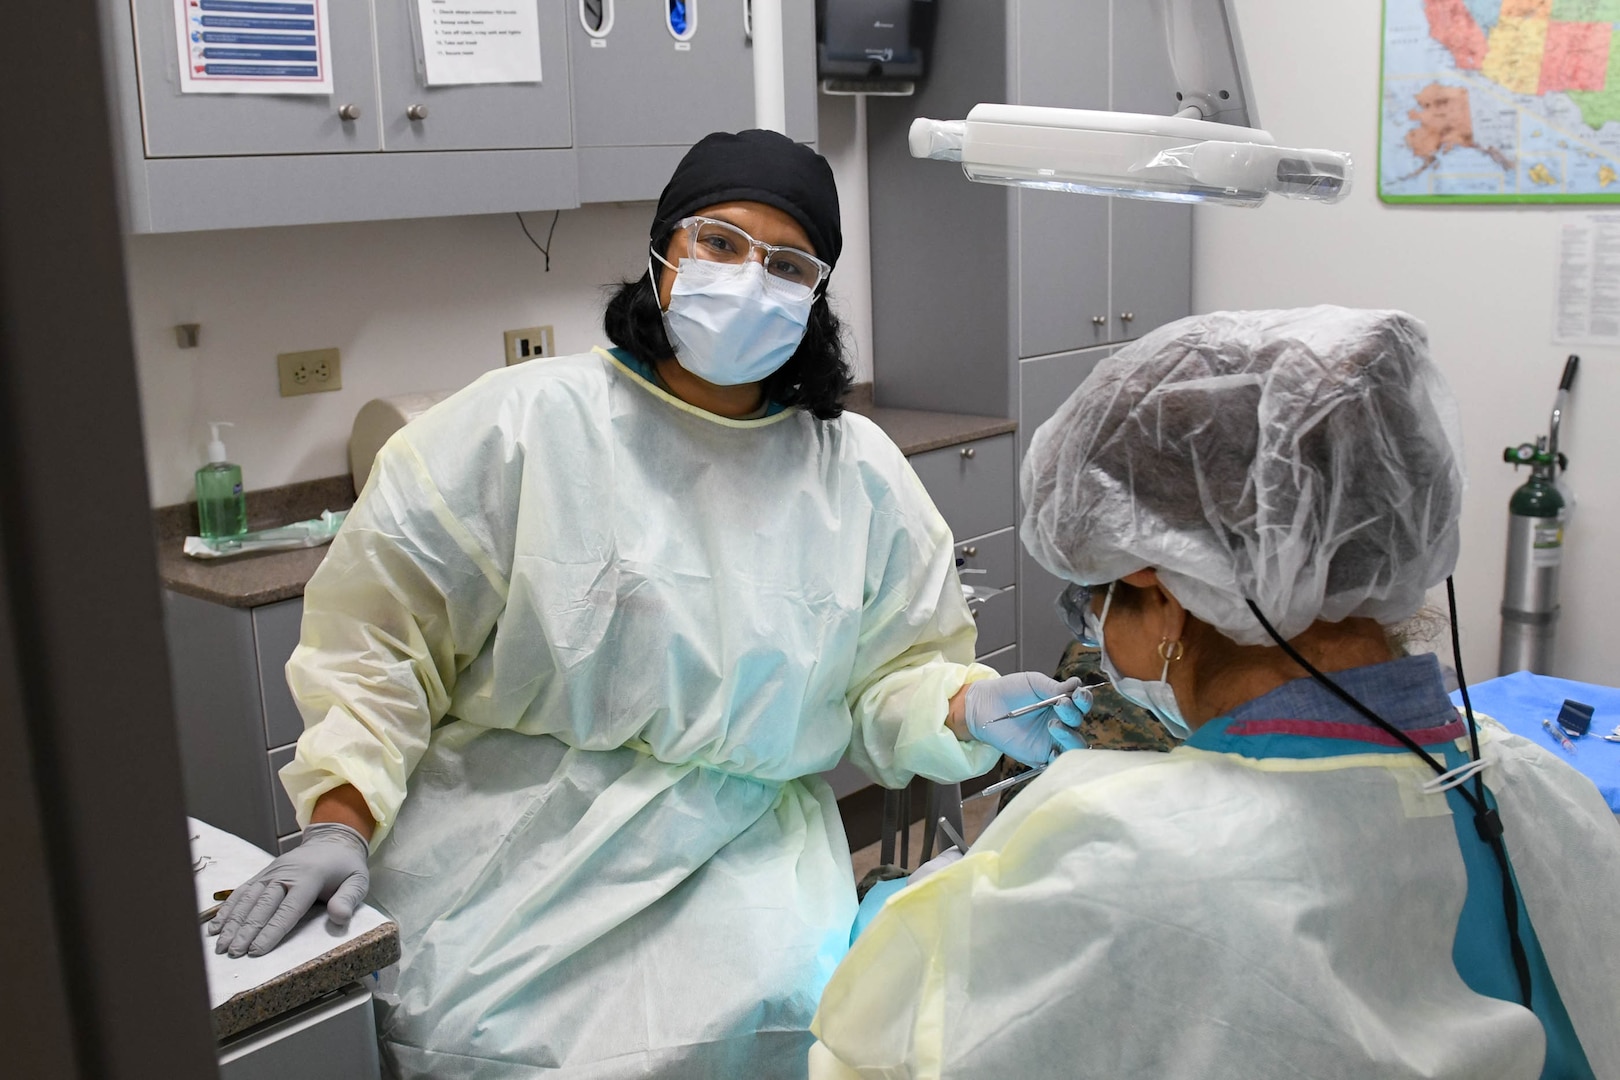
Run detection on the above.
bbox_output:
[154,382,1017,607]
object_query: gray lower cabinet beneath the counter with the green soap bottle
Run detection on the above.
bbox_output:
[164,591,303,852]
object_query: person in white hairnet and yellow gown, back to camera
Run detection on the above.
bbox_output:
[812,308,1620,1080]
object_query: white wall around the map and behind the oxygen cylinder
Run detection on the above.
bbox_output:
[1192,0,1620,683]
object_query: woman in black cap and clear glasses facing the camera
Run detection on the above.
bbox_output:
[214,131,1081,1080]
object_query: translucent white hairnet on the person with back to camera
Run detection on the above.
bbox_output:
[1022,306,1463,644]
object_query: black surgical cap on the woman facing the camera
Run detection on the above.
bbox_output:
[651,130,844,266]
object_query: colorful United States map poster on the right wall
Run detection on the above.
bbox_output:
[1379,0,1620,202]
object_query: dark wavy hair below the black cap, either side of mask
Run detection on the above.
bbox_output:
[603,242,855,419]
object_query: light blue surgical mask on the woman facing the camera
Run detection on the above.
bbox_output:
[653,257,815,387]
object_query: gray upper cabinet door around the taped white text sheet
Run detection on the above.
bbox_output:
[375,0,573,151]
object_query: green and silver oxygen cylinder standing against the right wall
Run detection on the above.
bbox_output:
[1497,356,1581,675]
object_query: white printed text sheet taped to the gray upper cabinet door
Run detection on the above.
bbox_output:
[416,0,539,86]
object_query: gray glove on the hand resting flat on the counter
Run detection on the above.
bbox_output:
[207,821,371,957]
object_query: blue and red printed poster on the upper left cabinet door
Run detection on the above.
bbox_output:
[175,0,332,94]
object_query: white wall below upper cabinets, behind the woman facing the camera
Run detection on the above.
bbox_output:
[126,97,872,505]
